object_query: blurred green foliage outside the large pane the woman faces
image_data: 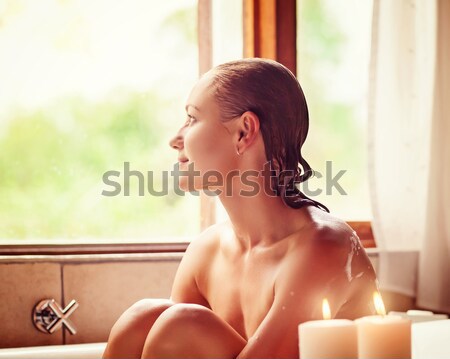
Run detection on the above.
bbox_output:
[0,90,198,238]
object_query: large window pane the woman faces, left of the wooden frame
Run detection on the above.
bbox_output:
[0,0,200,243]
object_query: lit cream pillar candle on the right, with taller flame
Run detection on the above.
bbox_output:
[355,293,411,359]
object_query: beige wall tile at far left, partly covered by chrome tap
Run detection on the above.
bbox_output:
[0,263,62,348]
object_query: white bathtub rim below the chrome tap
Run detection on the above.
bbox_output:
[0,343,106,359]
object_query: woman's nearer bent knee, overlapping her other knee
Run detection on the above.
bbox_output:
[142,304,247,359]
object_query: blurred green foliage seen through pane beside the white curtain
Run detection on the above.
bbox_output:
[297,0,368,219]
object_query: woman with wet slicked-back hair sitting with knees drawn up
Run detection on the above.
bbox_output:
[104,59,377,358]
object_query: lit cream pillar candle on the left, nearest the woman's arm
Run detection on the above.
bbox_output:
[298,299,358,359]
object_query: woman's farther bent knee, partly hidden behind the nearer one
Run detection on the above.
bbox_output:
[103,299,173,359]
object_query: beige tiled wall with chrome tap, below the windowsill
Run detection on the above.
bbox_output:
[0,254,181,348]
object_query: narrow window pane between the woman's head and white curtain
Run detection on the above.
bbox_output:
[297,0,372,221]
